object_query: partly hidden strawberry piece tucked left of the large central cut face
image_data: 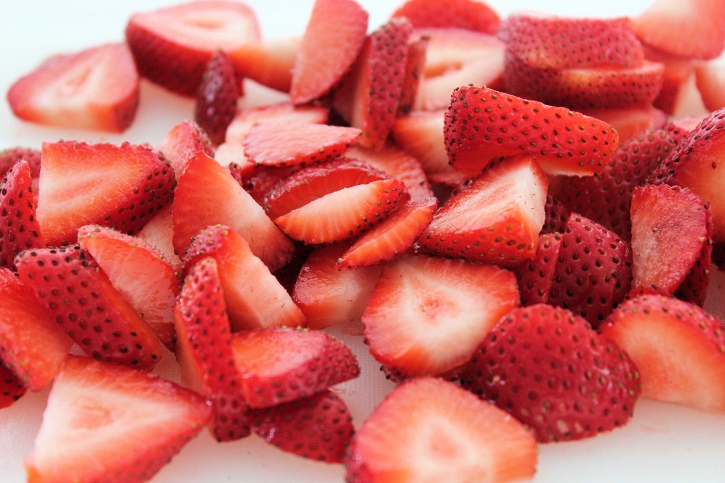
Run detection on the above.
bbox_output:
[292,244,383,329]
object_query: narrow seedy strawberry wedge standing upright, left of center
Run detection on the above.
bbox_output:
[174,258,251,442]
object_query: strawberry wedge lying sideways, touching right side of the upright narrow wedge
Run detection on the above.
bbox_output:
[232,328,360,408]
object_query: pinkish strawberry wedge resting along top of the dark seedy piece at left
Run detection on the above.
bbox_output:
[78,225,179,351]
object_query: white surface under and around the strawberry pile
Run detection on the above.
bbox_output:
[0,0,725,483]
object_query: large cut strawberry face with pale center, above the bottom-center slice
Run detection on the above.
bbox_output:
[362,255,519,377]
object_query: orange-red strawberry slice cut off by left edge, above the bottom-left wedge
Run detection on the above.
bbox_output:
[0,268,73,392]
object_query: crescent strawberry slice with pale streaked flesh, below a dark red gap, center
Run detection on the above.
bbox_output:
[274,179,409,244]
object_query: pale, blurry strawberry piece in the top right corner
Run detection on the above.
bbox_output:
[632,0,725,59]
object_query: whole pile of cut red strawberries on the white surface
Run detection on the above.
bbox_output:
[0,0,725,482]
